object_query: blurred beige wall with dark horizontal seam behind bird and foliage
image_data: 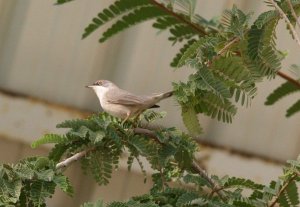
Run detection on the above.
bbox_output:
[0,0,300,206]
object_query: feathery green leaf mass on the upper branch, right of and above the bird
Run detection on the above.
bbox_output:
[56,0,300,134]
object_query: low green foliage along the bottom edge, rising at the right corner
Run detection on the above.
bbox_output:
[90,156,300,207]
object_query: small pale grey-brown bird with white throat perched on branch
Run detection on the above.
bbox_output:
[86,80,173,123]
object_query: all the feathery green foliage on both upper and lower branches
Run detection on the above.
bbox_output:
[5,0,300,207]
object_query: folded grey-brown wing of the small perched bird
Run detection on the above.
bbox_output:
[106,89,145,106]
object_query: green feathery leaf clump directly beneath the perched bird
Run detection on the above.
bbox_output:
[33,110,196,190]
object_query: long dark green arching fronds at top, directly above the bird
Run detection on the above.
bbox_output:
[82,0,202,43]
